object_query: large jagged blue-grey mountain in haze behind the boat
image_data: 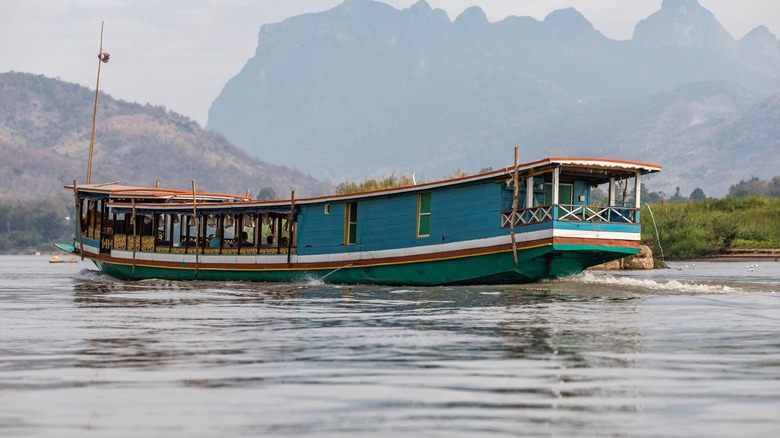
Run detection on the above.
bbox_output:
[207,0,780,195]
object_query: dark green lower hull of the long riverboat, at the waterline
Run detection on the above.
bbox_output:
[64,241,638,286]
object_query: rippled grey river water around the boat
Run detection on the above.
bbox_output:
[0,256,780,437]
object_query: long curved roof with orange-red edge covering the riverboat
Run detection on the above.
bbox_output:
[65,157,662,208]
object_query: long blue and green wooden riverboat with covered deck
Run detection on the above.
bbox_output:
[56,158,661,286]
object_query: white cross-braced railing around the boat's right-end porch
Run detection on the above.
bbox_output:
[501,204,639,228]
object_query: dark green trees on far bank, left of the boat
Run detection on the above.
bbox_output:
[0,196,75,253]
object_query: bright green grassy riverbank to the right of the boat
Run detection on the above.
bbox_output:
[642,196,780,259]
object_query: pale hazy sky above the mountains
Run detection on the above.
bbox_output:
[0,0,780,124]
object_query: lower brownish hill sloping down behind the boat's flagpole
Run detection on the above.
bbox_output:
[0,72,332,197]
